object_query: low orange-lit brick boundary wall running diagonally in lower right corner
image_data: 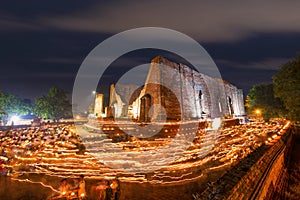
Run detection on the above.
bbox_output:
[198,129,292,199]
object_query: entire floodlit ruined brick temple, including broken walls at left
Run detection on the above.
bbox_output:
[95,56,245,122]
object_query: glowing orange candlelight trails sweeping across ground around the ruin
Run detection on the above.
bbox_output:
[0,119,289,198]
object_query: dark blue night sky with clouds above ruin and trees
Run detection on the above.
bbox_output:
[0,0,300,99]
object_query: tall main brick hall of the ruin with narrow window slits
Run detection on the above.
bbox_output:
[140,56,245,122]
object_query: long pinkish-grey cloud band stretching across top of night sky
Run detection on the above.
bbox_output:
[41,0,300,42]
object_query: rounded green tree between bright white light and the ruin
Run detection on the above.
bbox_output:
[34,87,72,120]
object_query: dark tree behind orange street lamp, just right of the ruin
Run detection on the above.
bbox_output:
[247,84,286,121]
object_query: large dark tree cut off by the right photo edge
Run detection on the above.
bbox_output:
[273,56,300,121]
